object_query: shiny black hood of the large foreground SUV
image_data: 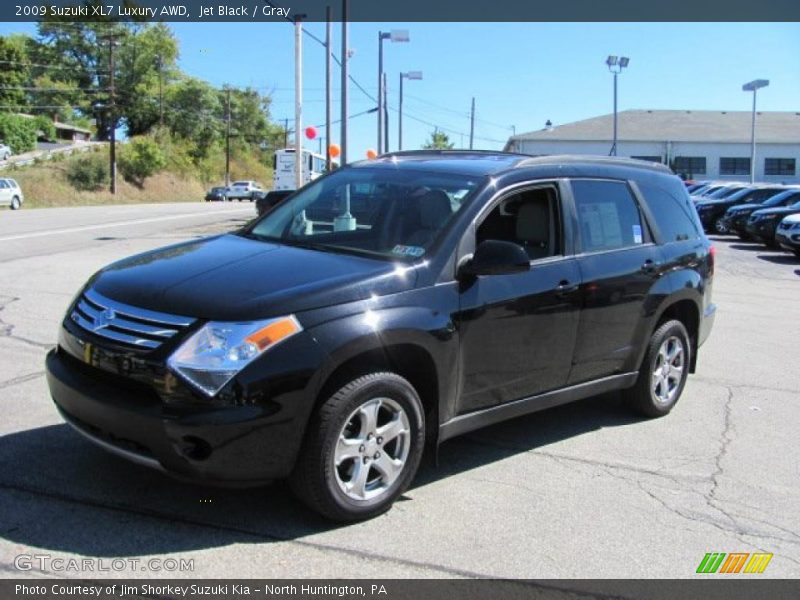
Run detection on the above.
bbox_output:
[89,234,417,321]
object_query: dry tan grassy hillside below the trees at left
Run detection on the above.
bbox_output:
[0,142,272,208]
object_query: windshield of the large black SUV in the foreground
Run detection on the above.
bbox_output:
[244,168,481,260]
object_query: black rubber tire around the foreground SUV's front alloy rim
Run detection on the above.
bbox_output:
[289,373,425,522]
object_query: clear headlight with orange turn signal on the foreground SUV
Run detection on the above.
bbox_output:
[167,316,303,396]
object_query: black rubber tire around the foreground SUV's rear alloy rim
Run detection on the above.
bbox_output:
[623,320,692,417]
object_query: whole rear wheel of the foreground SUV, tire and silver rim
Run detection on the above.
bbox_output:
[623,320,691,417]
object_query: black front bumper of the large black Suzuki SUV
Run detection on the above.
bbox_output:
[46,349,313,486]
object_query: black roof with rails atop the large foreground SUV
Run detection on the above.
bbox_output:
[360,150,672,175]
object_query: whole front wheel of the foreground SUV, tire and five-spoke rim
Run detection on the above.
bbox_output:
[290,373,425,521]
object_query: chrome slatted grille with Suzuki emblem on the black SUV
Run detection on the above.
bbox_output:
[70,290,195,350]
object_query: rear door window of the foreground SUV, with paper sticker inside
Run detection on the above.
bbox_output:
[572,179,644,252]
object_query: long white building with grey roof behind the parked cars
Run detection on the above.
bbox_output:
[505,110,800,183]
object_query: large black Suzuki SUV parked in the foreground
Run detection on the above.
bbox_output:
[47,151,715,521]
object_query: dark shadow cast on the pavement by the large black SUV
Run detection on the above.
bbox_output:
[0,394,639,558]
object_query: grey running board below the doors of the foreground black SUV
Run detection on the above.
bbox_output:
[439,371,639,442]
